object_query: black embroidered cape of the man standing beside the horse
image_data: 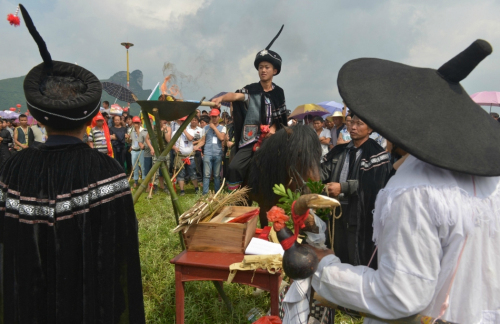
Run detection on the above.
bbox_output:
[321,139,392,269]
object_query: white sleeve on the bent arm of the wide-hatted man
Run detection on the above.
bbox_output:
[312,190,442,319]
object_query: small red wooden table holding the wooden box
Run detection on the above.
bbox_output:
[170,251,281,323]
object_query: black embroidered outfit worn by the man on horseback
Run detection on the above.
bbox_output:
[231,82,287,154]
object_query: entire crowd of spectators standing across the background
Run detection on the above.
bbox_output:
[7,102,500,200]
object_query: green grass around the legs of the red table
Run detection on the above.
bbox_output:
[135,186,360,324]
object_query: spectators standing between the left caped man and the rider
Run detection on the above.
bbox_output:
[72,106,234,195]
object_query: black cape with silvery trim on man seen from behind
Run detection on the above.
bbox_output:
[0,143,145,324]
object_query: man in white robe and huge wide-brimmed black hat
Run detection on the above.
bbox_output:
[304,40,500,323]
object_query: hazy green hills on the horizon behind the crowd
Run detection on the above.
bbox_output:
[0,70,152,115]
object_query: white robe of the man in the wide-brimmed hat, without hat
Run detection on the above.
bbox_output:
[312,156,500,323]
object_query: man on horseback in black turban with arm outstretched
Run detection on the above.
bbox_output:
[212,26,287,190]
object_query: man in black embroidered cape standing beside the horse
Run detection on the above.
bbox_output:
[321,115,391,269]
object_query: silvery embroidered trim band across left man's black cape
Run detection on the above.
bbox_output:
[0,174,130,226]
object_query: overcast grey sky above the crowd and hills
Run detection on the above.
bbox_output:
[0,0,500,111]
